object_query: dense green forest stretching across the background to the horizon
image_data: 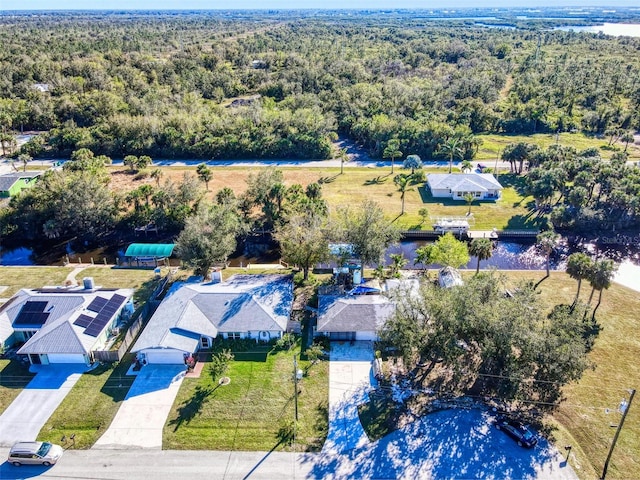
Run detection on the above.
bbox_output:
[0,13,640,158]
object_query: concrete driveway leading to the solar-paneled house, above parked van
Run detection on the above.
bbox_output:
[0,364,87,446]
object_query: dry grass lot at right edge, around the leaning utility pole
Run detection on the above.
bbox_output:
[488,271,640,480]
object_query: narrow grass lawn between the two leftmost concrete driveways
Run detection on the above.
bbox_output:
[38,355,135,449]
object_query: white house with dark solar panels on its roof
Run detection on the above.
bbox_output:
[0,279,133,365]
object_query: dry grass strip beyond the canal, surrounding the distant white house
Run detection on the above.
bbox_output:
[111,166,537,230]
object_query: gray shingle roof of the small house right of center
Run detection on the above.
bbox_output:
[317,295,395,332]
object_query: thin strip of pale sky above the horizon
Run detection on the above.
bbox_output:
[0,0,640,11]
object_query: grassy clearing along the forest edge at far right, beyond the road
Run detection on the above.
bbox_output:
[474,132,640,160]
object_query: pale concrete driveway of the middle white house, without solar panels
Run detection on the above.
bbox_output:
[93,365,186,449]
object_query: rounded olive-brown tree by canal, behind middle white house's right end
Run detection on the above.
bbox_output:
[274,211,329,281]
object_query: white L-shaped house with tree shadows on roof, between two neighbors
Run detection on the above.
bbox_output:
[136,275,293,364]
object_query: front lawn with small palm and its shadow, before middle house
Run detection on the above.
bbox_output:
[163,347,329,451]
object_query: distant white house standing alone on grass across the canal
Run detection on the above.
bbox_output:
[427,173,502,200]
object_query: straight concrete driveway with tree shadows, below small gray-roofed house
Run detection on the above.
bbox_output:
[323,341,375,454]
